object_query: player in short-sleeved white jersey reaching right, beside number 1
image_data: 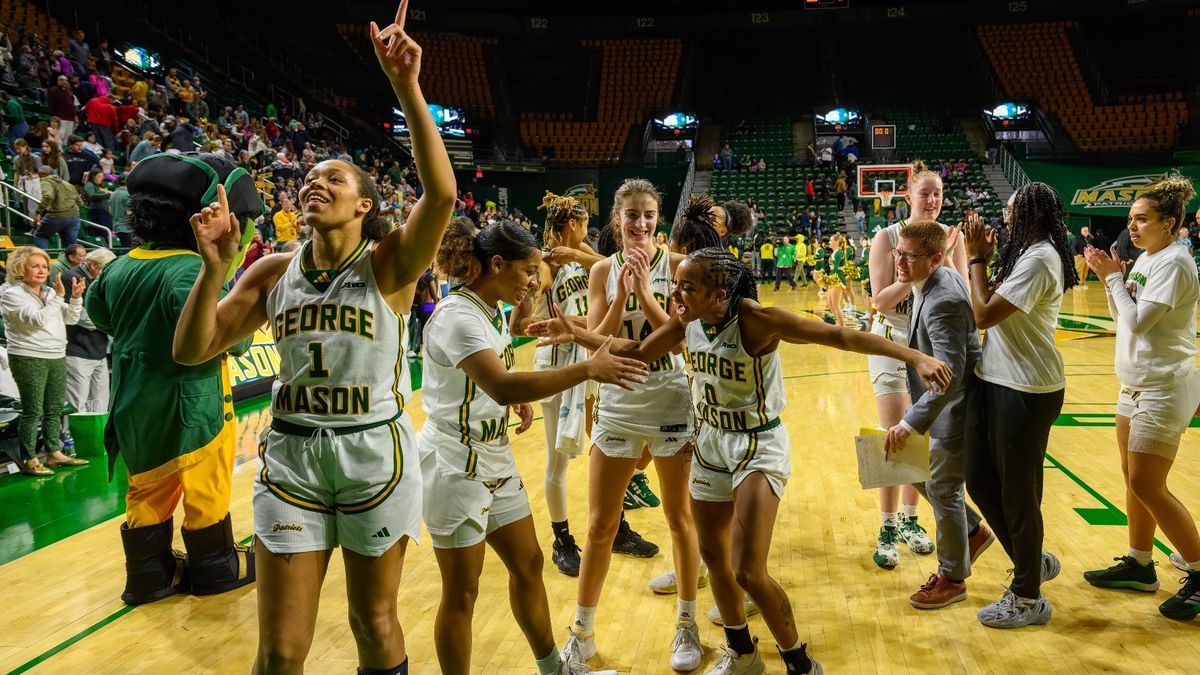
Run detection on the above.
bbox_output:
[418,219,646,675]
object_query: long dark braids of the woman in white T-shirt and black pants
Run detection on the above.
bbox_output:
[990,183,1079,291]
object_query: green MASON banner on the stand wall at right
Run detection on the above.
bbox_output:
[1021,161,1200,216]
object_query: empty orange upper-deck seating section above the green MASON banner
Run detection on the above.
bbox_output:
[977,22,1188,151]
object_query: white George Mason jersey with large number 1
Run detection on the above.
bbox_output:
[266,239,413,428]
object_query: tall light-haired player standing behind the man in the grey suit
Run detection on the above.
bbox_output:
[866,160,995,569]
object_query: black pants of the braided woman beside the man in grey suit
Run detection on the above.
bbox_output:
[965,375,1064,598]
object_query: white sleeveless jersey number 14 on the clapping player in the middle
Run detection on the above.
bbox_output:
[598,249,692,432]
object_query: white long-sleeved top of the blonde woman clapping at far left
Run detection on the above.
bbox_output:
[0,283,83,359]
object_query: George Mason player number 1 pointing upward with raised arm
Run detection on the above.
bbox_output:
[174,0,456,674]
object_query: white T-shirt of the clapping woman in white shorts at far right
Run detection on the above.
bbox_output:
[1116,244,1200,389]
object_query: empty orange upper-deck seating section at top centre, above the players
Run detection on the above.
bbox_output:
[521,40,683,165]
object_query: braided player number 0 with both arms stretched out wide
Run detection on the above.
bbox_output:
[530,237,950,675]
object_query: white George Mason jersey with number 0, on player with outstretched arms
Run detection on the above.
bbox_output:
[688,298,787,431]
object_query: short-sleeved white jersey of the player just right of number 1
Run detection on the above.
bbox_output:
[421,287,516,479]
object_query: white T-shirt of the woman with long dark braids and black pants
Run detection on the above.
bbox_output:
[976,241,1067,394]
